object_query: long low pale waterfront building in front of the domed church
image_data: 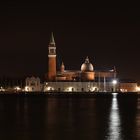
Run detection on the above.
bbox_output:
[44,82,118,92]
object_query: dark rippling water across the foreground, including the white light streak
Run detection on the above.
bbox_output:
[0,95,140,140]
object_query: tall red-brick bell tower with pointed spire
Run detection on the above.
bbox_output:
[48,33,56,81]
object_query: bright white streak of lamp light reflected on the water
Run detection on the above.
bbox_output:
[107,93,121,140]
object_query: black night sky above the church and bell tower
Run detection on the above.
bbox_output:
[0,1,140,82]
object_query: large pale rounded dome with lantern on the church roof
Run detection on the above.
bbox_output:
[81,57,93,72]
